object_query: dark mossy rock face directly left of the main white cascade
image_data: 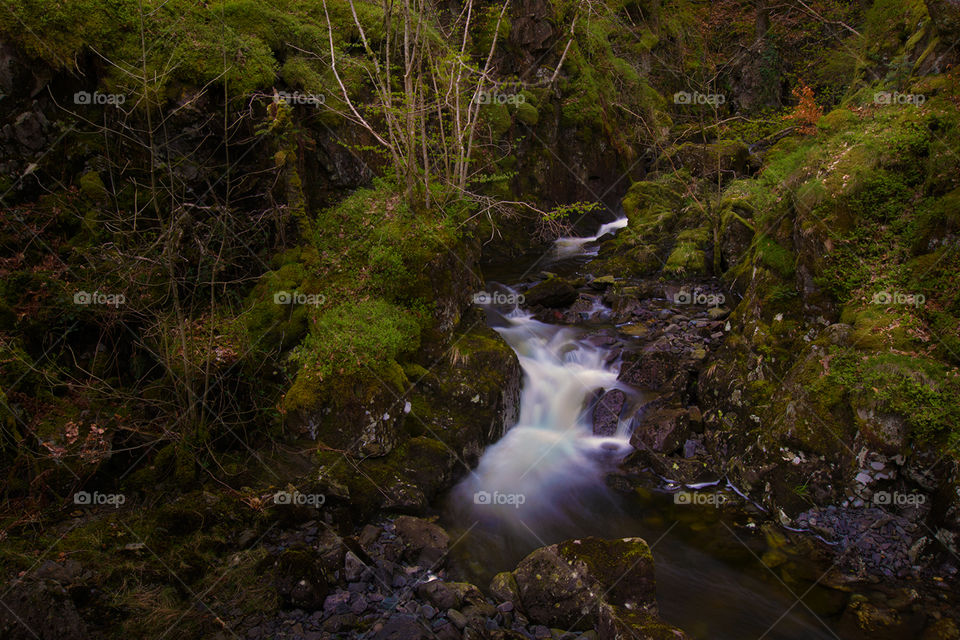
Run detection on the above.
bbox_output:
[317,311,521,517]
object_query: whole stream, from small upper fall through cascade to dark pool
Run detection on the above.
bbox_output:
[444,220,837,640]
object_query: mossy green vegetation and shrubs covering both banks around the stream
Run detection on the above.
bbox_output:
[0,0,960,637]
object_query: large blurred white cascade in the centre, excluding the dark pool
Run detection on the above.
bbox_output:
[453,310,631,532]
